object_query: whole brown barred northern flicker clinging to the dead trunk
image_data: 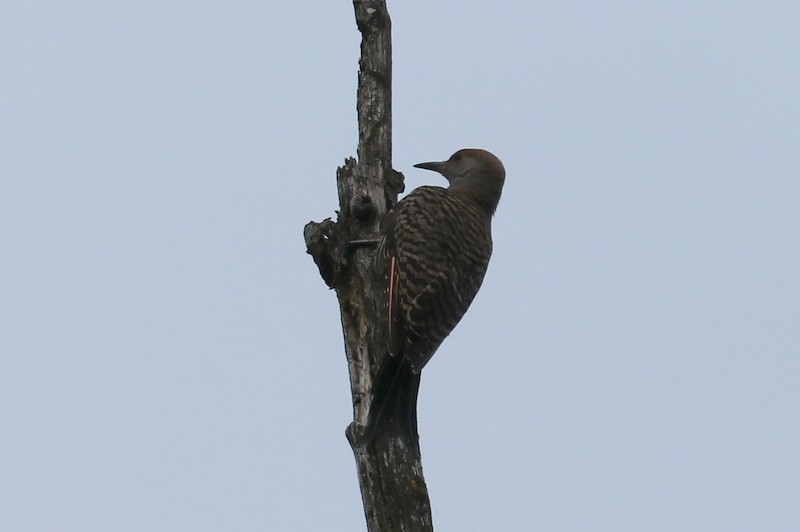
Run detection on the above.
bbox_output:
[365,149,505,439]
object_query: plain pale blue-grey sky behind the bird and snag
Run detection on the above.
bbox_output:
[0,0,800,532]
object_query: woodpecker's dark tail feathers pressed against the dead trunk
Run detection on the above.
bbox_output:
[364,353,420,442]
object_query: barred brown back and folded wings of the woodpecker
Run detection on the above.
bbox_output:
[381,187,491,372]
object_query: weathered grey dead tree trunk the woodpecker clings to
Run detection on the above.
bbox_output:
[304,0,433,532]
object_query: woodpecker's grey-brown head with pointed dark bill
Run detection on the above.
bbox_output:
[414,148,506,213]
